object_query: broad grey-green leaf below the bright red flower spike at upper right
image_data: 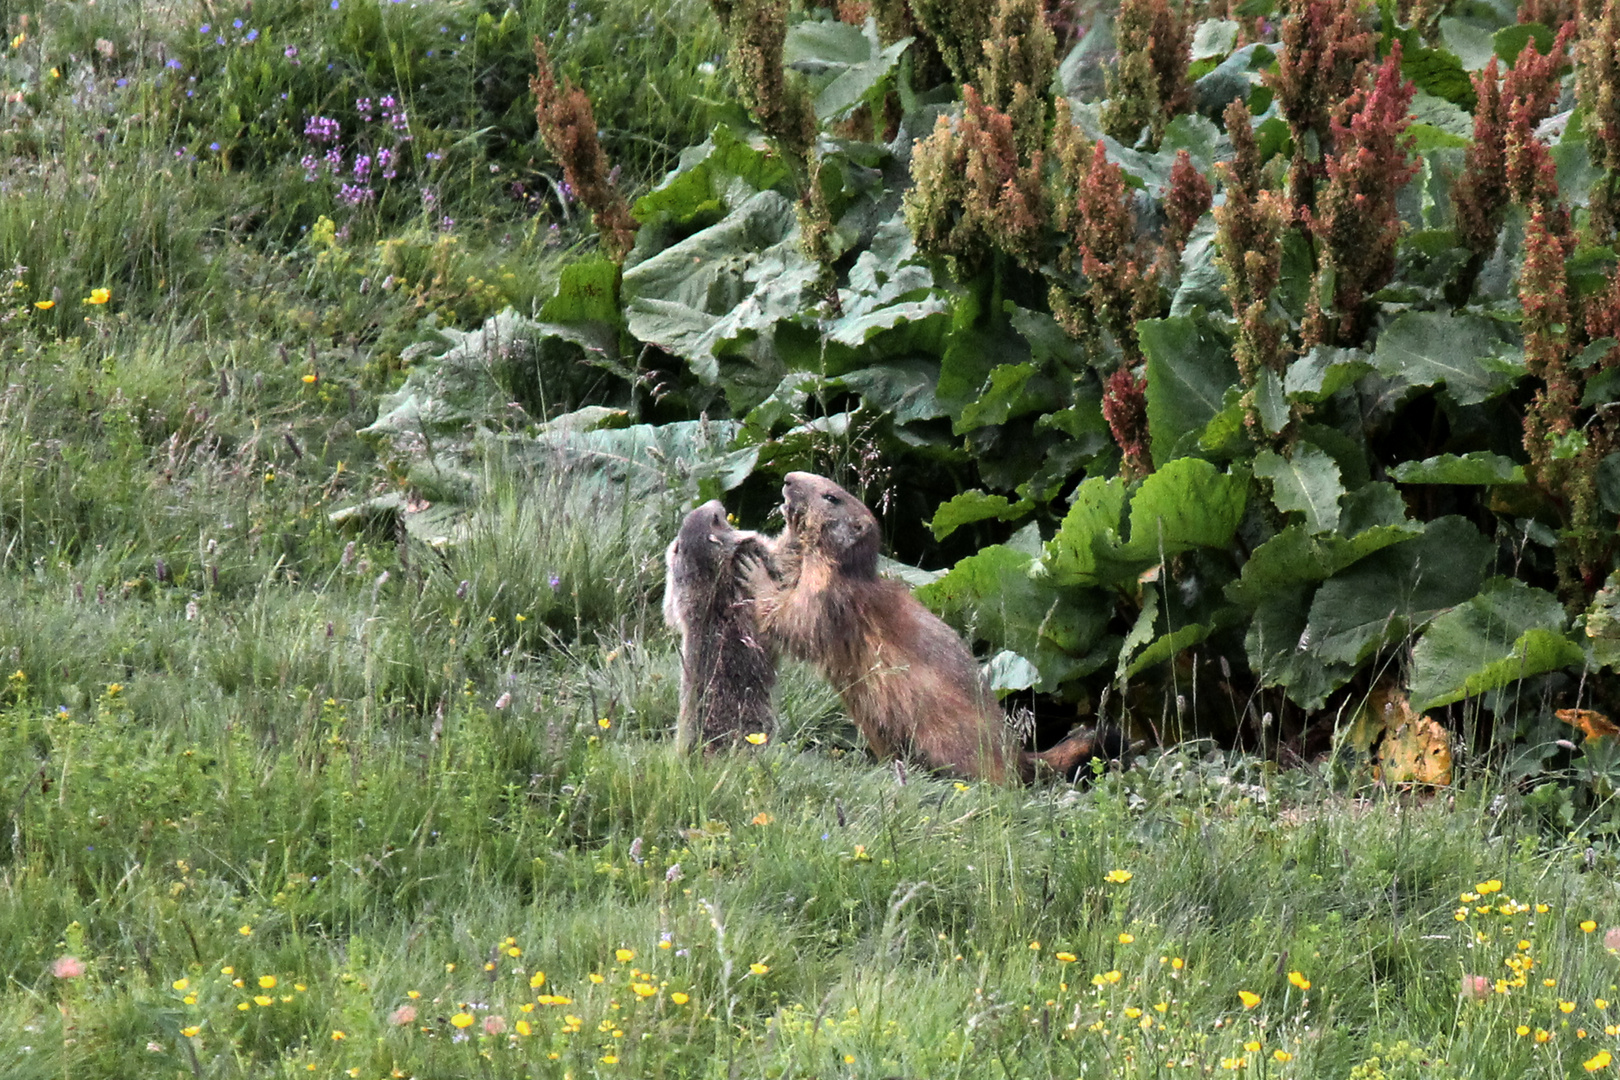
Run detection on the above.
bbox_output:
[1372,311,1524,405]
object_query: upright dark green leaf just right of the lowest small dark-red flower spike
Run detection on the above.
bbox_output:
[1136,316,1238,465]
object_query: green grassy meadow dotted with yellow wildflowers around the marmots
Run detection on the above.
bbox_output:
[9,0,1620,1080]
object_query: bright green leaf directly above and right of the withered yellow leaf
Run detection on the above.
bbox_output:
[1411,578,1584,712]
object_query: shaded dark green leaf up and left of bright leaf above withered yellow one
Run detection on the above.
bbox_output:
[1306,517,1495,665]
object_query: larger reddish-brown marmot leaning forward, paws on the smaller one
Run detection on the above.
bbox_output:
[748,473,1095,782]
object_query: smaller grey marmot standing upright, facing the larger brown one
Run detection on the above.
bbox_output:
[664,500,776,751]
